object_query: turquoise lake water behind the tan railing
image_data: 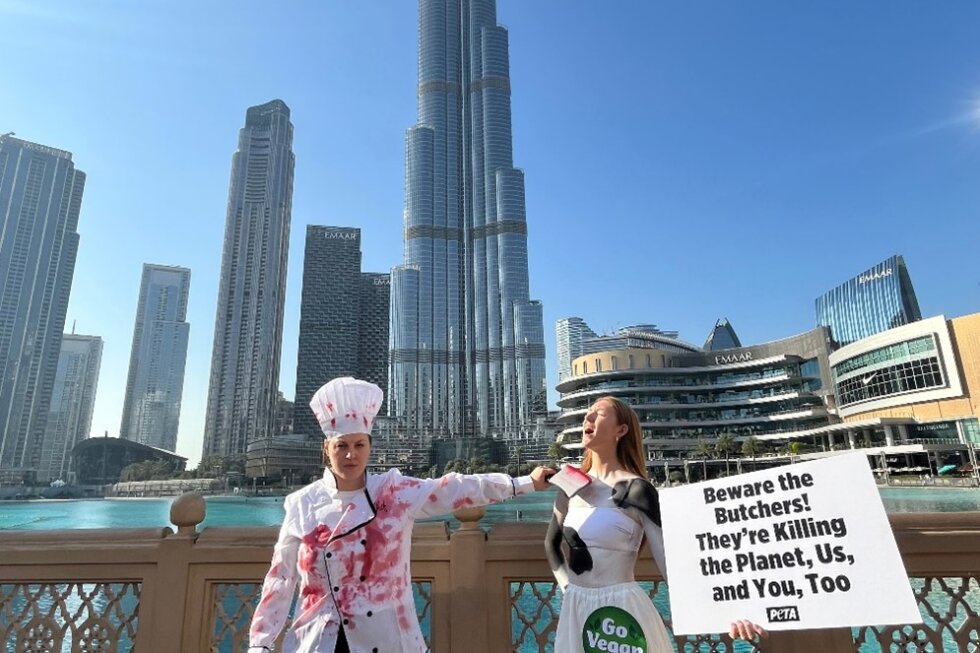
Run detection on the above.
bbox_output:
[0,488,980,530]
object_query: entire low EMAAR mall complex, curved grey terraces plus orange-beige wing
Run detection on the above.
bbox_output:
[557,314,980,476]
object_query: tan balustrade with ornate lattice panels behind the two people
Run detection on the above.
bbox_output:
[0,495,980,653]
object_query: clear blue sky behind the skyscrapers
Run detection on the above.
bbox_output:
[0,0,980,465]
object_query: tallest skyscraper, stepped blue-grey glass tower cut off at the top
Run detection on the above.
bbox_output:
[389,0,546,436]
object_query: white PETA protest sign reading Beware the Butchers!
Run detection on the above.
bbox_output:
[660,453,922,635]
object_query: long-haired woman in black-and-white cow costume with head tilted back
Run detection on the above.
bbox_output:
[545,397,765,653]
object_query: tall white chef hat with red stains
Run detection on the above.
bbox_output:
[310,376,384,438]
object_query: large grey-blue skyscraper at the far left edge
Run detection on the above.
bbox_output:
[0,135,85,481]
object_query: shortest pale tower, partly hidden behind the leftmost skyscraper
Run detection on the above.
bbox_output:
[38,333,102,482]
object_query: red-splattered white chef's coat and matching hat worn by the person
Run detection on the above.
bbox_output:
[249,378,533,653]
